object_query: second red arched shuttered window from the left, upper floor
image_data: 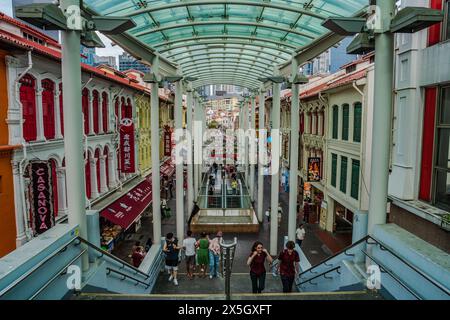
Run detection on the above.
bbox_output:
[42,79,55,140]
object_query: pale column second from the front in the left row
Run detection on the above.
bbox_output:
[150,83,161,245]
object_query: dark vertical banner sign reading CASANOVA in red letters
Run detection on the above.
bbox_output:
[31,161,55,234]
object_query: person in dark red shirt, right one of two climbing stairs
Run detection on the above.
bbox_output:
[278,241,300,292]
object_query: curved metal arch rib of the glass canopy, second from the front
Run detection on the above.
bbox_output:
[133,20,316,40]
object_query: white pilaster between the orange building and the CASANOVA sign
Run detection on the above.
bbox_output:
[11,161,28,247]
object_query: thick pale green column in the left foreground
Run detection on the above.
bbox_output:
[61,0,87,271]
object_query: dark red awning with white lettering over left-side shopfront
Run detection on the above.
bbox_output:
[100,175,152,230]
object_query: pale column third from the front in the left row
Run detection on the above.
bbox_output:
[174,81,185,241]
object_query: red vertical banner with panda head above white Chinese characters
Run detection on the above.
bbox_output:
[120,118,135,173]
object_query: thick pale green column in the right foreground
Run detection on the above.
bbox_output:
[368,0,395,234]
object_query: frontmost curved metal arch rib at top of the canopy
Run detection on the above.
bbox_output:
[121,0,327,20]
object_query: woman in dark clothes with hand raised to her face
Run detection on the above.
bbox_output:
[247,241,273,293]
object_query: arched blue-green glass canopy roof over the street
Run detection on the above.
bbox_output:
[83,0,369,88]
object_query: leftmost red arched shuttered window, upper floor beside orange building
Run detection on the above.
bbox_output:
[19,74,37,141]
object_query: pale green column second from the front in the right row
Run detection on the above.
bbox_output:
[288,83,300,241]
